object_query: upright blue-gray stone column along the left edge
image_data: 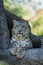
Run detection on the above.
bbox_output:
[0,0,10,49]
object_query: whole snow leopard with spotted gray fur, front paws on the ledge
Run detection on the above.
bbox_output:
[11,20,33,58]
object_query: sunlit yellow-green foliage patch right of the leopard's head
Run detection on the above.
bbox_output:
[30,16,43,35]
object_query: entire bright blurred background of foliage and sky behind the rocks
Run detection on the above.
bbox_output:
[4,0,43,35]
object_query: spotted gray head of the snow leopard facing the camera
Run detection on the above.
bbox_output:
[12,20,30,36]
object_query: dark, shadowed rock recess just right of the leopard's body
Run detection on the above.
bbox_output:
[30,33,41,48]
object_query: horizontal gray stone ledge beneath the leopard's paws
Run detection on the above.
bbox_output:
[0,48,43,65]
